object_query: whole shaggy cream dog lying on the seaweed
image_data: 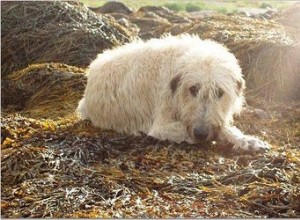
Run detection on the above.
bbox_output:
[77,35,268,151]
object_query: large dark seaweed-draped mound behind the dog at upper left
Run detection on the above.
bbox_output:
[1,1,131,75]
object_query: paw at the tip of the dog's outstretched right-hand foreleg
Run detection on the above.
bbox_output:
[233,136,270,152]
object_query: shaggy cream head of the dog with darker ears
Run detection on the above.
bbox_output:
[169,42,245,142]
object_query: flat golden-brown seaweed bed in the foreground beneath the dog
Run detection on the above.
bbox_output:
[1,92,300,218]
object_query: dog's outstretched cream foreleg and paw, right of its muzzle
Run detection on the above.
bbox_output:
[219,126,269,152]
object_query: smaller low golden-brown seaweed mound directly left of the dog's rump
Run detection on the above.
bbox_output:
[1,63,86,117]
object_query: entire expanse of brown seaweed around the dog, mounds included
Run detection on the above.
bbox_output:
[1,1,300,218]
